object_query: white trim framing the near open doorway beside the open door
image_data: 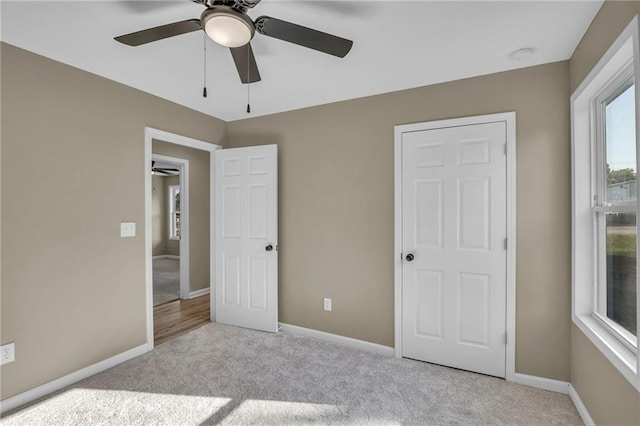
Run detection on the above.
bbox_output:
[144,127,222,350]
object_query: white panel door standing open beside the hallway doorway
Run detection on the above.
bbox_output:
[214,145,278,332]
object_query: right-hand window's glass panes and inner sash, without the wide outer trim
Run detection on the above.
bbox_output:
[592,71,638,350]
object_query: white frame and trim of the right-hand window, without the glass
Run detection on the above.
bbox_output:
[571,16,640,390]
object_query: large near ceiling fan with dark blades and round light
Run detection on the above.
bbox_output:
[115,0,353,84]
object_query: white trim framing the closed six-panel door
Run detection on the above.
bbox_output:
[393,112,516,381]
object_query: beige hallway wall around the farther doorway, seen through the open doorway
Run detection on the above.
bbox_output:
[153,140,210,291]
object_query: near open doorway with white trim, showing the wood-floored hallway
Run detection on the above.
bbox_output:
[145,128,218,349]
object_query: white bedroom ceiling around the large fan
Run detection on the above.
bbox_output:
[1,0,602,121]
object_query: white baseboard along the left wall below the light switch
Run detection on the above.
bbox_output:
[0,343,149,413]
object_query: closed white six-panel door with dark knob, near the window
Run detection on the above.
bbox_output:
[402,122,507,377]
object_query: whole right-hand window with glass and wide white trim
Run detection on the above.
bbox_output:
[571,17,640,390]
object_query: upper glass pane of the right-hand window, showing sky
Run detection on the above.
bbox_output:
[605,85,638,205]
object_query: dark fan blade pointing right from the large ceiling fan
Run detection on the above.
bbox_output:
[255,16,353,58]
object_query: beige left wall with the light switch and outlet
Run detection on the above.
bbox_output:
[0,44,225,399]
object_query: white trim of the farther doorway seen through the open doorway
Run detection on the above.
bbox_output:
[151,154,191,299]
